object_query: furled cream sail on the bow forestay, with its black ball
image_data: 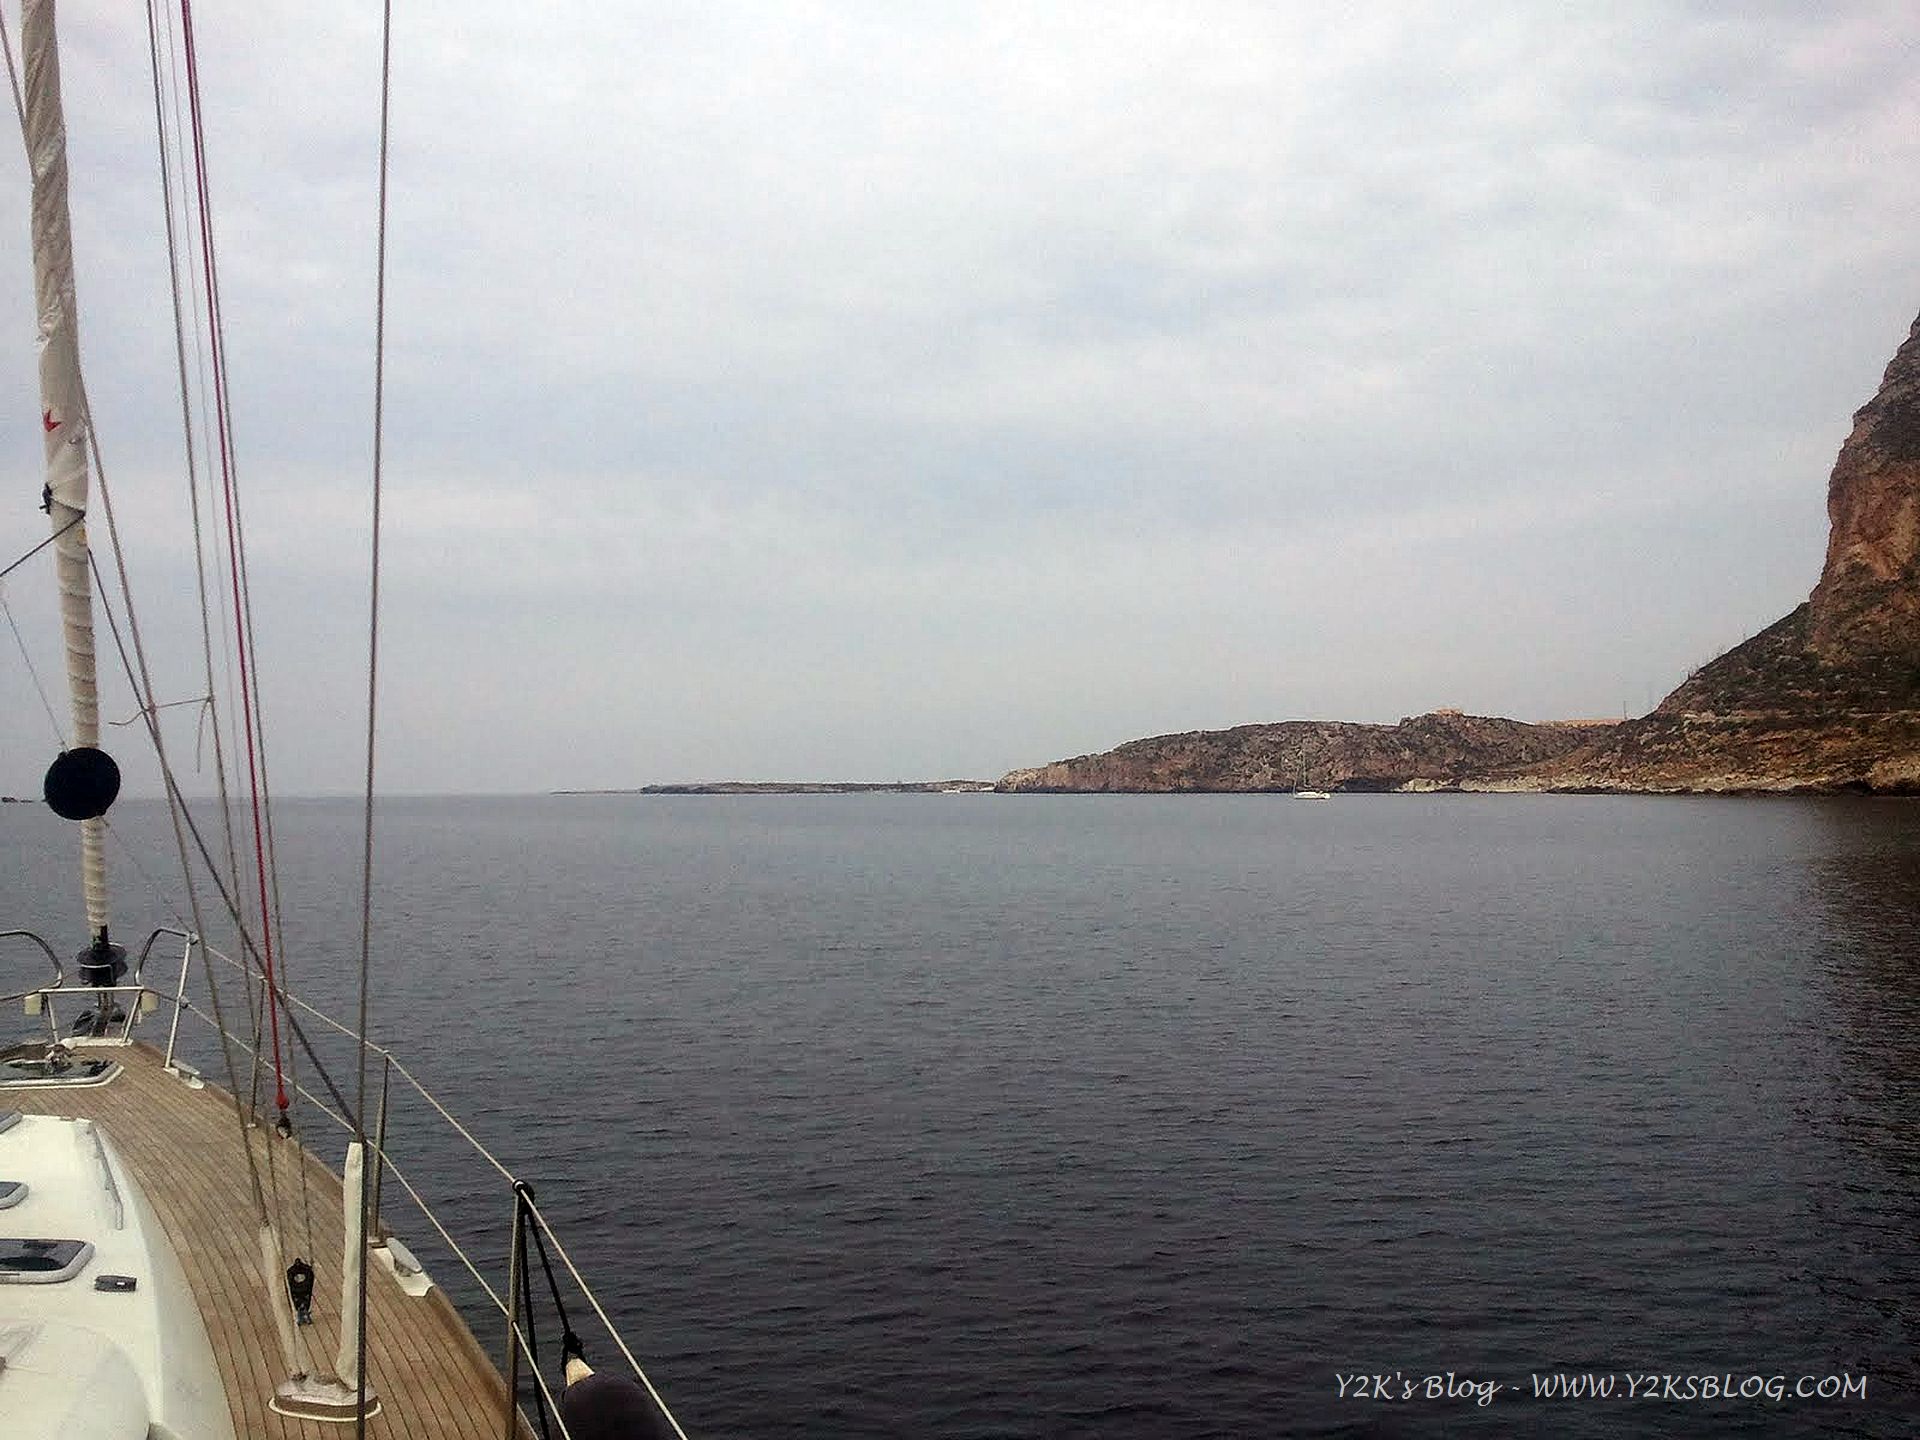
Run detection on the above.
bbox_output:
[21,0,119,983]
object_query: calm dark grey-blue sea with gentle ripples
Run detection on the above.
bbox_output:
[0,795,1920,1438]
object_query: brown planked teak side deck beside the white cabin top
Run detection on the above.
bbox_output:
[0,1044,507,1440]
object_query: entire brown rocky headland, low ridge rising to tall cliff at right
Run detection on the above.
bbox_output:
[998,309,1920,795]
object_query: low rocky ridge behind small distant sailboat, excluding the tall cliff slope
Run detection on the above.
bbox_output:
[998,710,1611,793]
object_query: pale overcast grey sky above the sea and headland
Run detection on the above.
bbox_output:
[0,0,1920,793]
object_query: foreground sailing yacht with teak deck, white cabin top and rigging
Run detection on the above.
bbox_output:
[0,0,682,1440]
